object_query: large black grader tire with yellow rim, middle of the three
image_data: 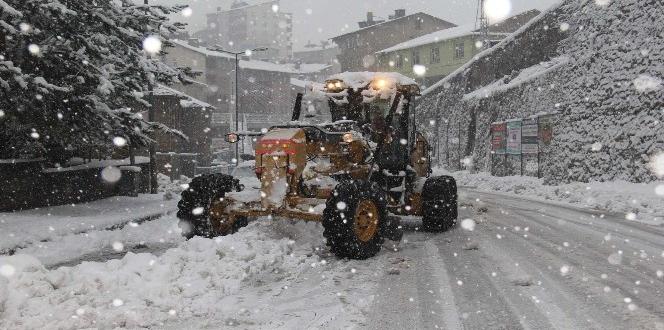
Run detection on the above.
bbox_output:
[323,181,387,259]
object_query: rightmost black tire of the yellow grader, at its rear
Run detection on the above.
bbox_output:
[422,176,458,232]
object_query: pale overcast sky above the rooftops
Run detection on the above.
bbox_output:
[150,0,559,49]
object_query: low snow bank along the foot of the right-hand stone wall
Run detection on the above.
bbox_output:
[446,170,664,225]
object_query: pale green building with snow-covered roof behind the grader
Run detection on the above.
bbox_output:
[376,10,540,86]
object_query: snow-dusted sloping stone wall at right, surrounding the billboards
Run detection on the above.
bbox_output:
[420,0,664,182]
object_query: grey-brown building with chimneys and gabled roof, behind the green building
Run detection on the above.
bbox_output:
[332,9,456,71]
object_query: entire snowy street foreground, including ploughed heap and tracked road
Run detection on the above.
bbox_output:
[0,189,664,330]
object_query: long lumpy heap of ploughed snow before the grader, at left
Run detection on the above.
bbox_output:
[0,222,324,329]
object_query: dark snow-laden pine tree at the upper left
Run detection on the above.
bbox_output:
[0,0,191,160]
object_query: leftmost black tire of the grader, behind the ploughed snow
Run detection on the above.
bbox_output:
[177,174,247,239]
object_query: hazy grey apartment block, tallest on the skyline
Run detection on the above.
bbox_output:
[194,0,293,60]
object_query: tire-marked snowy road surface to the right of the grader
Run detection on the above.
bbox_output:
[367,190,664,329]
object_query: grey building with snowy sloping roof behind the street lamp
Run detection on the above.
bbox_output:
[163,39,304,156]
